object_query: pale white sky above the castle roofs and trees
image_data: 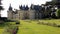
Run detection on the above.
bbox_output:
[1,0,51,17]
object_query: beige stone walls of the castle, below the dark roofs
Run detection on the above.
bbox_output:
[8,10,35,20]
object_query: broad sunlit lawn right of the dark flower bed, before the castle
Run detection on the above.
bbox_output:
[17,20,60,34]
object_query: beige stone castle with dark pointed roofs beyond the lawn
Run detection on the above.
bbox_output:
[8,4,43,20]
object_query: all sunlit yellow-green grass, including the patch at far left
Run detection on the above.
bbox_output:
[0,19,60,34]
